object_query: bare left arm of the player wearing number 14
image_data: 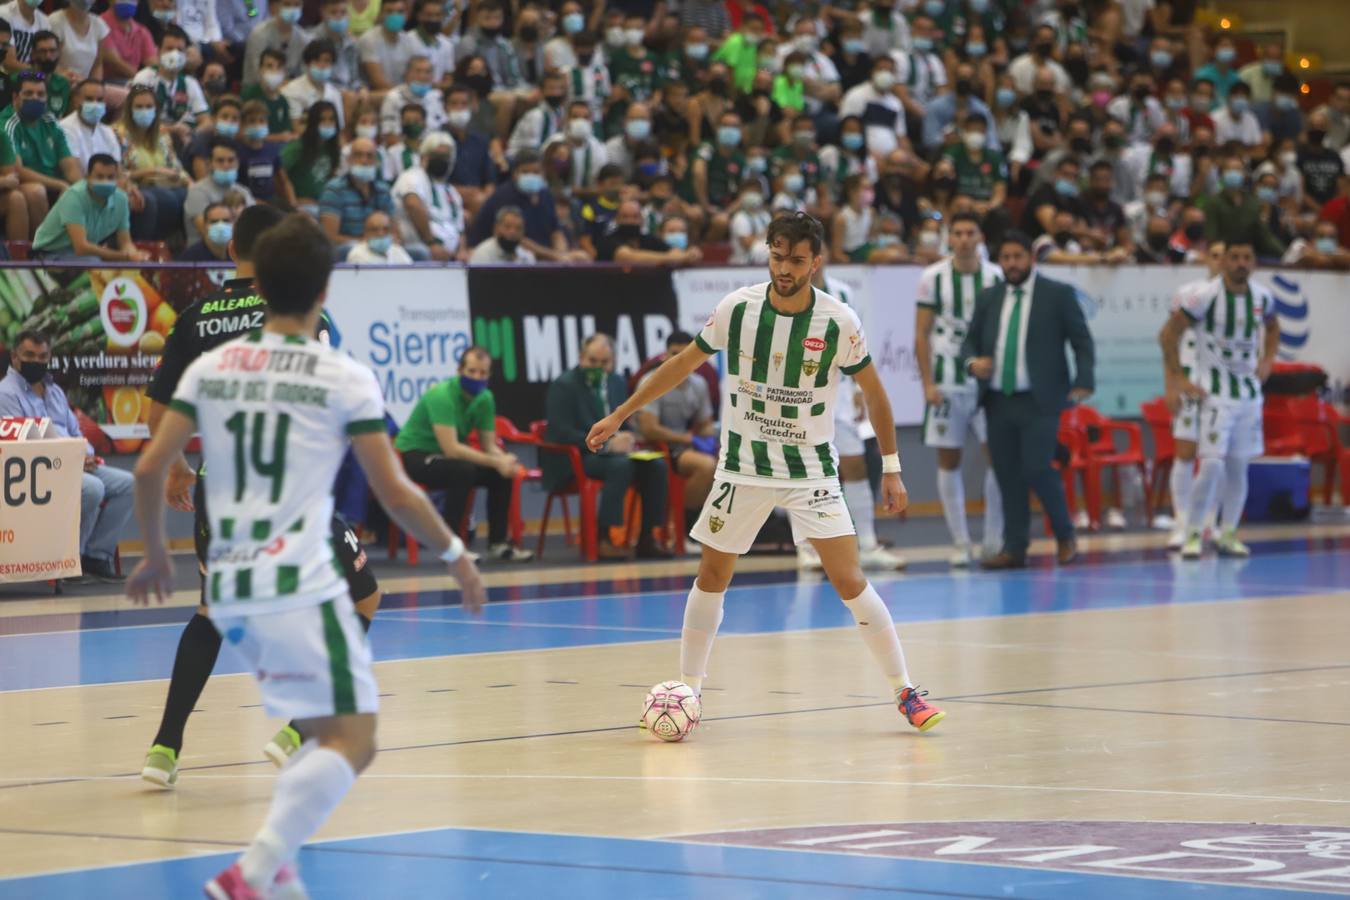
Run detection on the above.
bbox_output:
[127,409,197,603]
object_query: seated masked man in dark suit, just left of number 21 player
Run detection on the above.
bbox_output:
[539,335,671,559]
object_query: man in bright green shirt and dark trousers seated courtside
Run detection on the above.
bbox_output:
[394,347,535,563]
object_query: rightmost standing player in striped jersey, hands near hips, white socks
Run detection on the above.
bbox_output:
[1161,239,1280,560]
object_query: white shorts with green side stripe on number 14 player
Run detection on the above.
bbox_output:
[211,596,379,719]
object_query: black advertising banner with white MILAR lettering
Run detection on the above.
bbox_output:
[468,266,678,428]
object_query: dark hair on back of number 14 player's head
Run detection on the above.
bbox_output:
[252,213,333,316]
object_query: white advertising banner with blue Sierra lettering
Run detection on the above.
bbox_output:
[327,267,473,422]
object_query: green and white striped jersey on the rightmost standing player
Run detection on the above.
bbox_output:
[1180,277,1274,399]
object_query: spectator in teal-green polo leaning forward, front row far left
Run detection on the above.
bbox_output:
[32,152,150,262]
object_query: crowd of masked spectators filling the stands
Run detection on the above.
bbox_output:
[0,0,1350,266]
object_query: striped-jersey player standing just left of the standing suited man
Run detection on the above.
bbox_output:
[914,212,1003,568]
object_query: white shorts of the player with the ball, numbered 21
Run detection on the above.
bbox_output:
[690,472,855,556]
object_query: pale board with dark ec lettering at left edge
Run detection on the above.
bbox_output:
[0,437,85,582]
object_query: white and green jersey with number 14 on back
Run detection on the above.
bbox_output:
[170,331,385,615]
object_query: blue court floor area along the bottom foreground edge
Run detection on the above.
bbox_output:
[0,828,1330,900]
